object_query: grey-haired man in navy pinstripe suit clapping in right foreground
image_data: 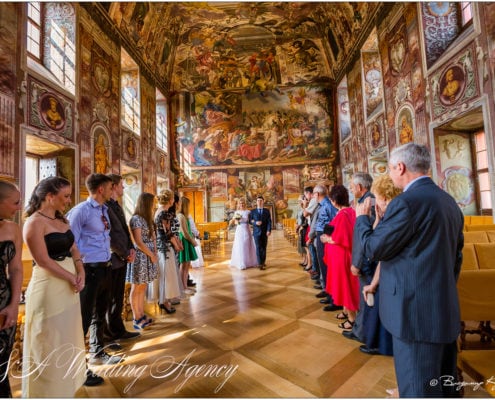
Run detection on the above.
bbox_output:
[354,143,464,397]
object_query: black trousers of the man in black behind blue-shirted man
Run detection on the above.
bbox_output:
[105,266,127,337]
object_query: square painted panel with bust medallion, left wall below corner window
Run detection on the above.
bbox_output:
[28,76,74,140]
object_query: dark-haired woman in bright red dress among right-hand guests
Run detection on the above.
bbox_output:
[321,185,359,329]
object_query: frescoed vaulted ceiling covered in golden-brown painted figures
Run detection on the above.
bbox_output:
[88,2,385,91]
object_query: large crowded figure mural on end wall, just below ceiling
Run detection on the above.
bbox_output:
[175,87,333,167]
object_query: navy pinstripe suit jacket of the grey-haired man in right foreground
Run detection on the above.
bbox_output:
[354,177,464,343]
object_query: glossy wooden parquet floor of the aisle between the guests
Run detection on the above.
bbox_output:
[11,231,492,398]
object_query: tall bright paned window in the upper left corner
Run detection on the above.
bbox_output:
[27,2,76,93]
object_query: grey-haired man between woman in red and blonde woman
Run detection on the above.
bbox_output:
[342,172,376,342]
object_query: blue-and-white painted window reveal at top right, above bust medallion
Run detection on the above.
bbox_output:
[421,2,459,68]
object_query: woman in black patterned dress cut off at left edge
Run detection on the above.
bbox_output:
[0,180,22,398]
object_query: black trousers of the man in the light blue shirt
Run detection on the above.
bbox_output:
[80,264,112,353]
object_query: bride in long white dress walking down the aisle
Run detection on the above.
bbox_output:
[230,199,258,269]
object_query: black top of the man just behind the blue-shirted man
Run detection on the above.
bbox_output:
[106,199,134,269]
